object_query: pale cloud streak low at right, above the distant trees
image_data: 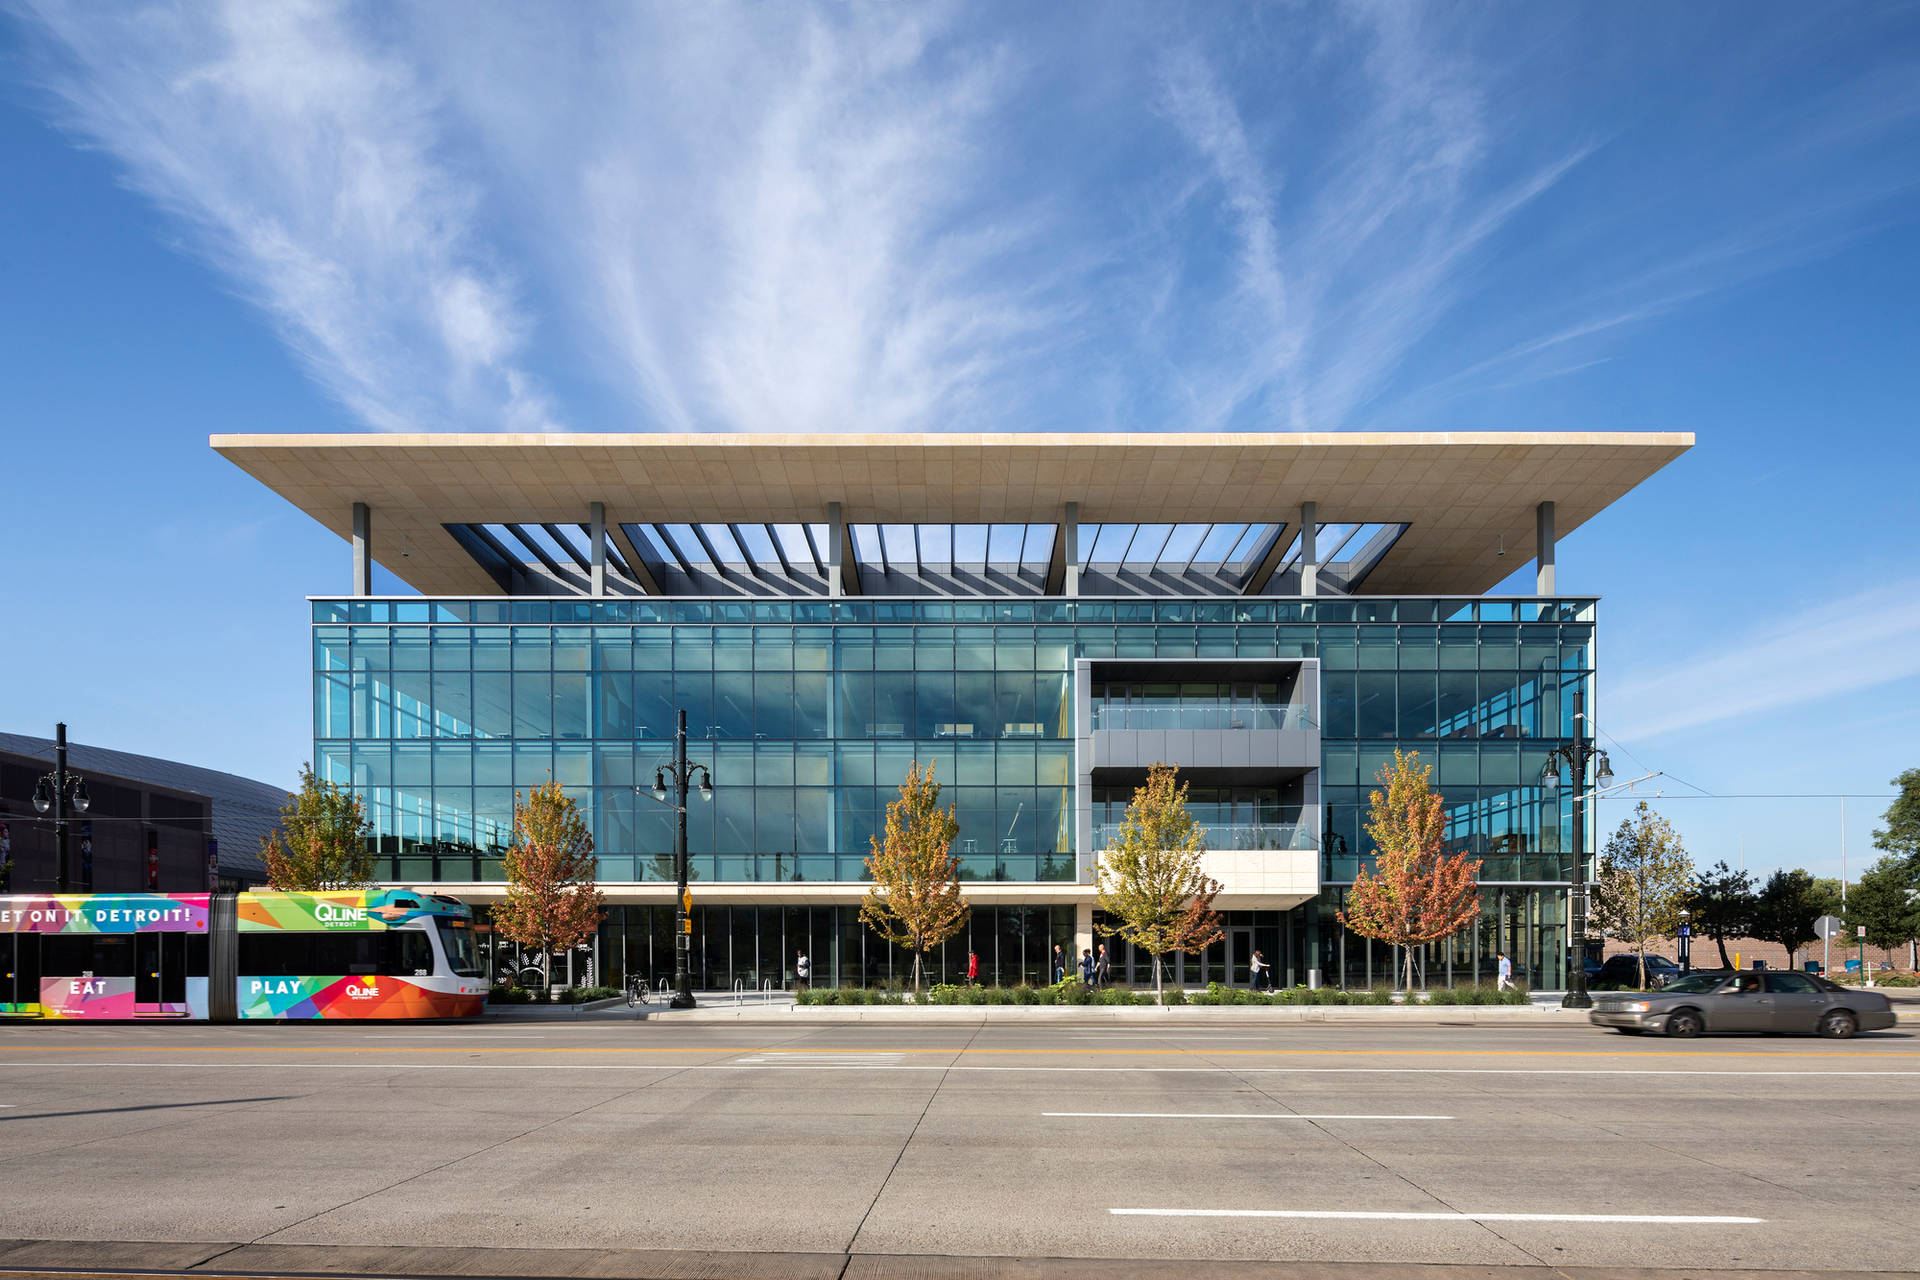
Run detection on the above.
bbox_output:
[1607,578,1920,743]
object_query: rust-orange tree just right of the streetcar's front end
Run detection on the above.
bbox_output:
[493,783,607,973]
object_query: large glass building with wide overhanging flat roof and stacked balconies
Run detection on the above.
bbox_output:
[215,436,1684,990]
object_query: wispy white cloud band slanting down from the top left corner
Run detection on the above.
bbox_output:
[18,0,551,430]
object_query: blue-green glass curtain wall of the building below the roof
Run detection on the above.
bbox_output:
[313,599,1596,986]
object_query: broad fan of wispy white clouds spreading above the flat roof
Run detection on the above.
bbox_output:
[15,0,1920,430]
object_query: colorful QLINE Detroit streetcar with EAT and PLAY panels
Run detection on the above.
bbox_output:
[0,889,488,1023]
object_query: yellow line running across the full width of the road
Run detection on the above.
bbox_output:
[0,1044,1920,1061]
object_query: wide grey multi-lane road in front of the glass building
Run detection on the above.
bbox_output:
[0,1021,1920,1276]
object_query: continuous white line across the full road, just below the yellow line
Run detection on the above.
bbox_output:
[0,1050,1920,1080]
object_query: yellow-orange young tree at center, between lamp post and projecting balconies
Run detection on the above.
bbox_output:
[860,760,972,990]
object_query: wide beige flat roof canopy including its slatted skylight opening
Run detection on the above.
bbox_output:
[211,432,1693,597]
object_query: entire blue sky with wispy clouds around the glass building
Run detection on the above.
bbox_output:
[0,0,1920,877]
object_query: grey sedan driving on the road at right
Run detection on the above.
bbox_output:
[1588,969,1893,1040]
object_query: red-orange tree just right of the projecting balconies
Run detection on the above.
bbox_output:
[1340,748,1480,992]
